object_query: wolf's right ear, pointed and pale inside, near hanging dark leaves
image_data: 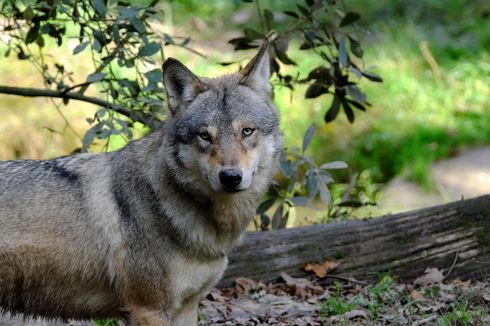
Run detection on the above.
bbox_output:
[240,42,272,97]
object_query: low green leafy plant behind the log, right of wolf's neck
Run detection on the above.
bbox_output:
[255,124,380,230]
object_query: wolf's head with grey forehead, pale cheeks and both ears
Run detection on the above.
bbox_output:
[163,46,283,195]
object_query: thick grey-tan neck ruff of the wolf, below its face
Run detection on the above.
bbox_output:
[128,132,267,258]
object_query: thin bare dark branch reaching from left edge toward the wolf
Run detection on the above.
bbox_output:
[0,86,157,125]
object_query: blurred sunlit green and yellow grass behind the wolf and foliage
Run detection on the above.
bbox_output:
[0,0,490,191]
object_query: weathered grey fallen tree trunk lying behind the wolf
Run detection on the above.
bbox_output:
[219,195,490,286]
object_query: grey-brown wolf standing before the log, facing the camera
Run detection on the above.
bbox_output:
[0,45,283,326]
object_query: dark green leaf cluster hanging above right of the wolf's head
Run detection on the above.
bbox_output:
[230,0,382,123]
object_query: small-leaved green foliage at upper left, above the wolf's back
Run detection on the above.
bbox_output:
[1,0,173,151]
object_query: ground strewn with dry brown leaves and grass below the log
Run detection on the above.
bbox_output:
[199,269,490,326]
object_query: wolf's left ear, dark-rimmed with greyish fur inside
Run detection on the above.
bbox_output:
[162,58,205,114]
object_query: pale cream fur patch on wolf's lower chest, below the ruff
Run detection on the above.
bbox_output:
[170,257,228,303]
